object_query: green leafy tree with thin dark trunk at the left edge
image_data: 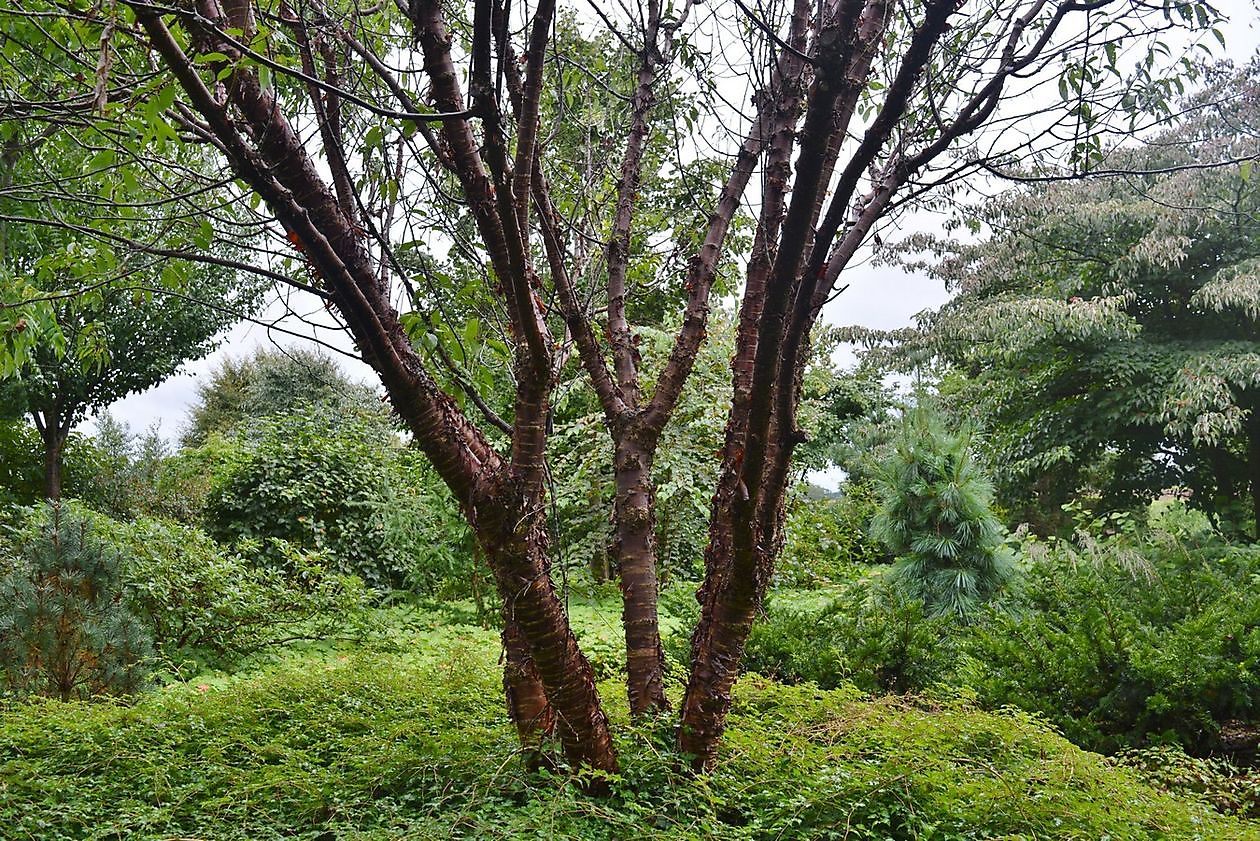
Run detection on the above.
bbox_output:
[0,21,260,499]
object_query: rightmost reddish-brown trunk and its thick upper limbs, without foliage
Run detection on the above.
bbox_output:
[679,0,1086,768]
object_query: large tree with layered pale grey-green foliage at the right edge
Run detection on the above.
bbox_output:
[861,64,1260,535]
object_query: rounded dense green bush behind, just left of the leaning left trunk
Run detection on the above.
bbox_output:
[205,415,473,593]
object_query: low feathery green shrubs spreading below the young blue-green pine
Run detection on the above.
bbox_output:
[745,521,1260,762]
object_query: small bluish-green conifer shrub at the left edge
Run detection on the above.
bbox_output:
[0,504,151,701]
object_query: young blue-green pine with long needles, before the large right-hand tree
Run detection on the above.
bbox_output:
[871,407,1014,617]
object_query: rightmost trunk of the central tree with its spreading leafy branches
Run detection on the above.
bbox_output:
[679,0,1215,767]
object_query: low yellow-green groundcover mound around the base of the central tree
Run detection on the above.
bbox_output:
[0,644,1260,841]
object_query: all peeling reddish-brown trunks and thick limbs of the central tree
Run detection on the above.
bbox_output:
[113,0,1094,770]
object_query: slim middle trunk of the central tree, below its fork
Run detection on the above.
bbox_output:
[612,432,669,717]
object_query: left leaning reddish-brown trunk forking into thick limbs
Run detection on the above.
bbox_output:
[129,0,616,770]
